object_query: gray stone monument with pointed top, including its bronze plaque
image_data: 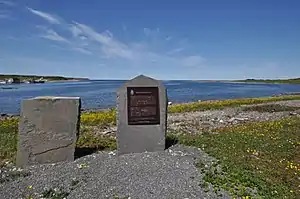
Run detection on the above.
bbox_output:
[117,75,167,155]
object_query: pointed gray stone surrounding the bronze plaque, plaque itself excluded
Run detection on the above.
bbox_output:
[117,75,167,155]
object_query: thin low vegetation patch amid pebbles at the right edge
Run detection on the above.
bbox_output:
[243,104,300,113]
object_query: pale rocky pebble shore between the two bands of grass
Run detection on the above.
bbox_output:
[83,100,300,137]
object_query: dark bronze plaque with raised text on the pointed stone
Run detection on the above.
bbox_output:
[127,87,160,125]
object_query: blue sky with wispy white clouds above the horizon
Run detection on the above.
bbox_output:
[0,0,300,80]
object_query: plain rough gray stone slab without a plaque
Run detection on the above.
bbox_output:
[16,97,81,167]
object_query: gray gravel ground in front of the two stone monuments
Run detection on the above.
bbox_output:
[0,145,230,199]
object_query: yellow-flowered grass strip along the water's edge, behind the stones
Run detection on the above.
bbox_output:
[0,95,300,166]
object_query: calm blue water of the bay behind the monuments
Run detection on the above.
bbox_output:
[0,80,300,114]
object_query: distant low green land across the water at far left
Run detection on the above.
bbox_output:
[0,74,87,81]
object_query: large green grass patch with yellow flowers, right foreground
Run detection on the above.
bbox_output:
[178,117,300,199]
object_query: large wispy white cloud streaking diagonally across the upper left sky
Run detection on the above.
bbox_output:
[28,8,204,67]
